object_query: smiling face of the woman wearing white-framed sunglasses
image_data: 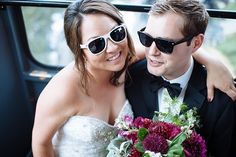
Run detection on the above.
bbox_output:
[81,14,129,73]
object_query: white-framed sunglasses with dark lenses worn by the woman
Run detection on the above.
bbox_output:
[80,24,127,55]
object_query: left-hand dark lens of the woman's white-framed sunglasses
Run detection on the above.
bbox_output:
[88,38,105,54]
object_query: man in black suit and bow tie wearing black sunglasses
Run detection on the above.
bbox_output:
[126,0,236,157]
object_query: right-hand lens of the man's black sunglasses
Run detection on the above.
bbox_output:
[155,39,173,54]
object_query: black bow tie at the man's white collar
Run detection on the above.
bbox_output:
[150,76,182,99]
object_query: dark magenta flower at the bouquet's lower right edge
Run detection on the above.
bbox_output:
[182,132,207,157]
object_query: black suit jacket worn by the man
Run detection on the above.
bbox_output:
[125,60,236,157]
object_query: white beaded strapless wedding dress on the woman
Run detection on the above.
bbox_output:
[52,100,133,157]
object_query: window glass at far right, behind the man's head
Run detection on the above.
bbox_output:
[203,18,236,76]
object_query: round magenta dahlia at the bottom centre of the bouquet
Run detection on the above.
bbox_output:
[143,134,168,154]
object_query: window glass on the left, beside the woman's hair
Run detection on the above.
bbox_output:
[22,7,73,66]
